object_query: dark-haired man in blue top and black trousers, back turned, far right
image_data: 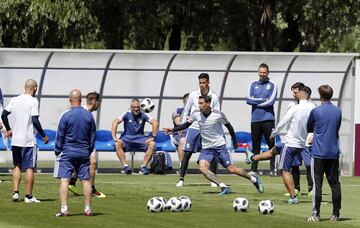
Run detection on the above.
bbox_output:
[307,85,341,222]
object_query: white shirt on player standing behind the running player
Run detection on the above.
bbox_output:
[181,89,220,129]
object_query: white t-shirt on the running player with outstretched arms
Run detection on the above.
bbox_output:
[188,110,228,149]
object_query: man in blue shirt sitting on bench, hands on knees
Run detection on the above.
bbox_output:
[111,99,159,175]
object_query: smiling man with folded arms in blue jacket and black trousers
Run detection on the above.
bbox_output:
[246,63,277,175]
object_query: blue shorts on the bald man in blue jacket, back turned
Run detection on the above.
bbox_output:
[54,151,90,180]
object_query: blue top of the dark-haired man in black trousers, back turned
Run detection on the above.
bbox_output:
[307,102,341,159]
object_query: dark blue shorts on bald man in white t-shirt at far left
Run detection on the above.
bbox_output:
[12,146,37,170]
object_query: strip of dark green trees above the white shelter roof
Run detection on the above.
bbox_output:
[0,0,360,52]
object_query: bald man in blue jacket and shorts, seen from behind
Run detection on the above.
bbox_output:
[54,89,96,217]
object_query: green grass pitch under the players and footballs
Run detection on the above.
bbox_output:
[0,174,360,228]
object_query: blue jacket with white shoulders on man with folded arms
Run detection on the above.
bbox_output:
[246,78,277,122]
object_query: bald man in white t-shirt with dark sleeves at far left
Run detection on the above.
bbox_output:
[1,79,49,203]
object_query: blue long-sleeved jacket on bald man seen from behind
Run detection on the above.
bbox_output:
[55,107,96,156]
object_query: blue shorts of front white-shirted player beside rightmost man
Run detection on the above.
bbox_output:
[276,144,303,172]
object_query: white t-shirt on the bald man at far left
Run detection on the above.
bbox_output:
[5,94,39,147]
